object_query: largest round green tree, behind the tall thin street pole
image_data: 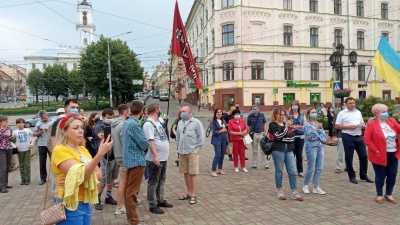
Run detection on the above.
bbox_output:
[80,36,143,107]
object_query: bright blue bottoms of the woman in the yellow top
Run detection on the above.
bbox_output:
[56,198,92,225]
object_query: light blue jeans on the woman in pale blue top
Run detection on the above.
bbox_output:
[304,146,324,187]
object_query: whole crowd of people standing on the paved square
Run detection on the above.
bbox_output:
[0,97,400,224]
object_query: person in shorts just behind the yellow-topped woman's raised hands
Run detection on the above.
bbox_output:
[93,108,119,210]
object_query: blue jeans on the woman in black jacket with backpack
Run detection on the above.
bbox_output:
[272,145,297,190]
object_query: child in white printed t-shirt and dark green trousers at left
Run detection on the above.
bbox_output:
[13,118,33,185]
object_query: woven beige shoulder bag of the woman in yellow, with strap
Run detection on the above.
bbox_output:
[40,165,67,225]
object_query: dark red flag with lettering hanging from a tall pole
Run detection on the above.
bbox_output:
[171,1,203,89]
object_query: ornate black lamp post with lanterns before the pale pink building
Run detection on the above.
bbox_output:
[329,44,357,106]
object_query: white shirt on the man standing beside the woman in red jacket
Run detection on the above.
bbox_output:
[336,109,365,136]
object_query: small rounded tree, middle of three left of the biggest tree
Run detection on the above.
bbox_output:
[43,65,69,99]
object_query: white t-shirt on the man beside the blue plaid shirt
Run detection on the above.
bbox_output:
[143,118,169,162]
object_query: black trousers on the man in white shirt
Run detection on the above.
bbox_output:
[342,133,368,180]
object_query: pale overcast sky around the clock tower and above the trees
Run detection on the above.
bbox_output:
[0,0,194,73]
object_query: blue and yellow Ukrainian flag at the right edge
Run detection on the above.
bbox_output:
[372,36,400,91]
